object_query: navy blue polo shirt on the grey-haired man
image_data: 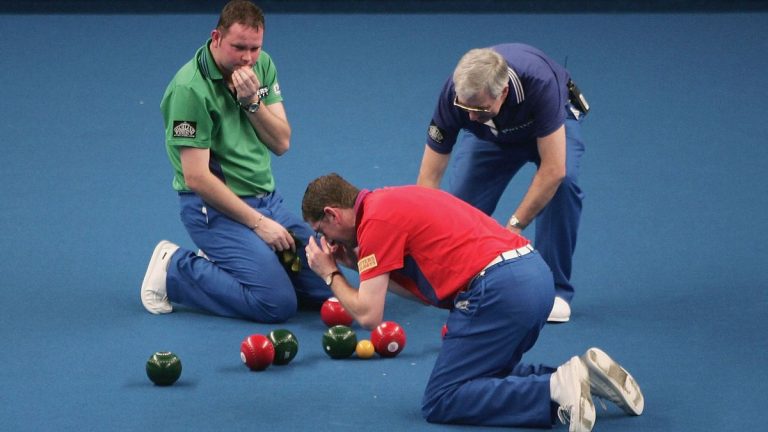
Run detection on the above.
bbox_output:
[427,43,570,154]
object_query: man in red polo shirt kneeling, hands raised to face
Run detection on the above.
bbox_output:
[302,174,644,431]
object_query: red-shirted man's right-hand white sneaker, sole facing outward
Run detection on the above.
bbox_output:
[581,348,645,415]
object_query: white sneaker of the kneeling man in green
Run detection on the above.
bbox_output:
[141,240,179,314]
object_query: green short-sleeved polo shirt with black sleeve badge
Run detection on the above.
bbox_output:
[160,39,283,196]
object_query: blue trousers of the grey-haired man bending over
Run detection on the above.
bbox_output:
[447,113,584,303]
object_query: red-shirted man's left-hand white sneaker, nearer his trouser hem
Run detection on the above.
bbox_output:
[549,356,595,432]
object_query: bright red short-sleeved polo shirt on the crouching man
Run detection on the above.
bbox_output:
[355,186,529,306]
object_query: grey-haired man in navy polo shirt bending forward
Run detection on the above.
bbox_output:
[418,43,588,322]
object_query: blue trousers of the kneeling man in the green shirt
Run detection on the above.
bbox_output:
[166,192,332,323]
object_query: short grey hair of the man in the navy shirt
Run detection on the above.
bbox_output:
[453,48,509,100]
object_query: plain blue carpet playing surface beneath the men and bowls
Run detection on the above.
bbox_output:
[0,13,768,431]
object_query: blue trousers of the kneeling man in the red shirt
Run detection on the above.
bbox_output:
[422,252,555,427]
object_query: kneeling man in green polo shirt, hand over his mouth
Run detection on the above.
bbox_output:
[141,0,331,322]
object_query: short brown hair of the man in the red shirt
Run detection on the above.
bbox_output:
[301,173,360,222]
